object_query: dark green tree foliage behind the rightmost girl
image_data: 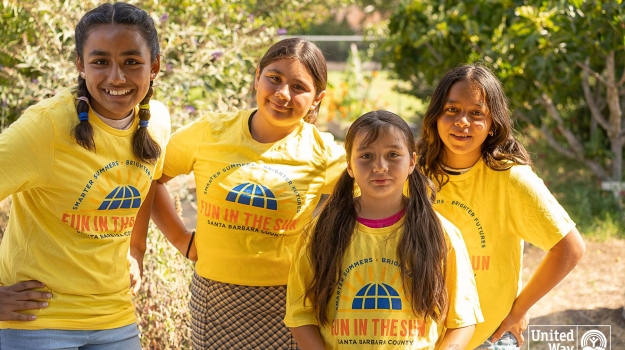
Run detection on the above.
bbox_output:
[383,0,625,180]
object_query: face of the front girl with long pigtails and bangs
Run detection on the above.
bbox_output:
[347,128,417,205]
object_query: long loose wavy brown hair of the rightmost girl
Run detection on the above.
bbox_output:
[417,64,532,188]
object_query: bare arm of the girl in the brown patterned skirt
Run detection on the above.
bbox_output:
[152,175,197,261]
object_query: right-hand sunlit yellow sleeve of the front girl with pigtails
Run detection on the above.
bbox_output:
[439,216,484,328]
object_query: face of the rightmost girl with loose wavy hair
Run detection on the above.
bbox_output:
[436,80,492,169]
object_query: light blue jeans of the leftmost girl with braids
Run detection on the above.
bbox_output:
[0,323,141,350]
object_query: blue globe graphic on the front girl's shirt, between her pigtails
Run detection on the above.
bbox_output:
[352,283,401,310]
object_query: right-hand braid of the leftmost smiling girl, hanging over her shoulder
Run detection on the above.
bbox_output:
[132,80,161,164]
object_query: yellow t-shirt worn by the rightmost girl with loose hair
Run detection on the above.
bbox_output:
[435,159,575,349]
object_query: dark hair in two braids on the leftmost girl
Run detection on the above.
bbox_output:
[73,2,161,164]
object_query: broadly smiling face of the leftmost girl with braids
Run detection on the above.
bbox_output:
[76,24,160,119]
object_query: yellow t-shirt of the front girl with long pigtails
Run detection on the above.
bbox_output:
[284,216,482,350]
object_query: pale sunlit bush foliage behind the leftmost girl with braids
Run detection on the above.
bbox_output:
[0,0,339,130]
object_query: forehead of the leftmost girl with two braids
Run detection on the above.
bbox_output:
[84,24,150,55]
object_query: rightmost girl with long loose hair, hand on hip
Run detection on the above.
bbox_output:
[417,64,585,349]
